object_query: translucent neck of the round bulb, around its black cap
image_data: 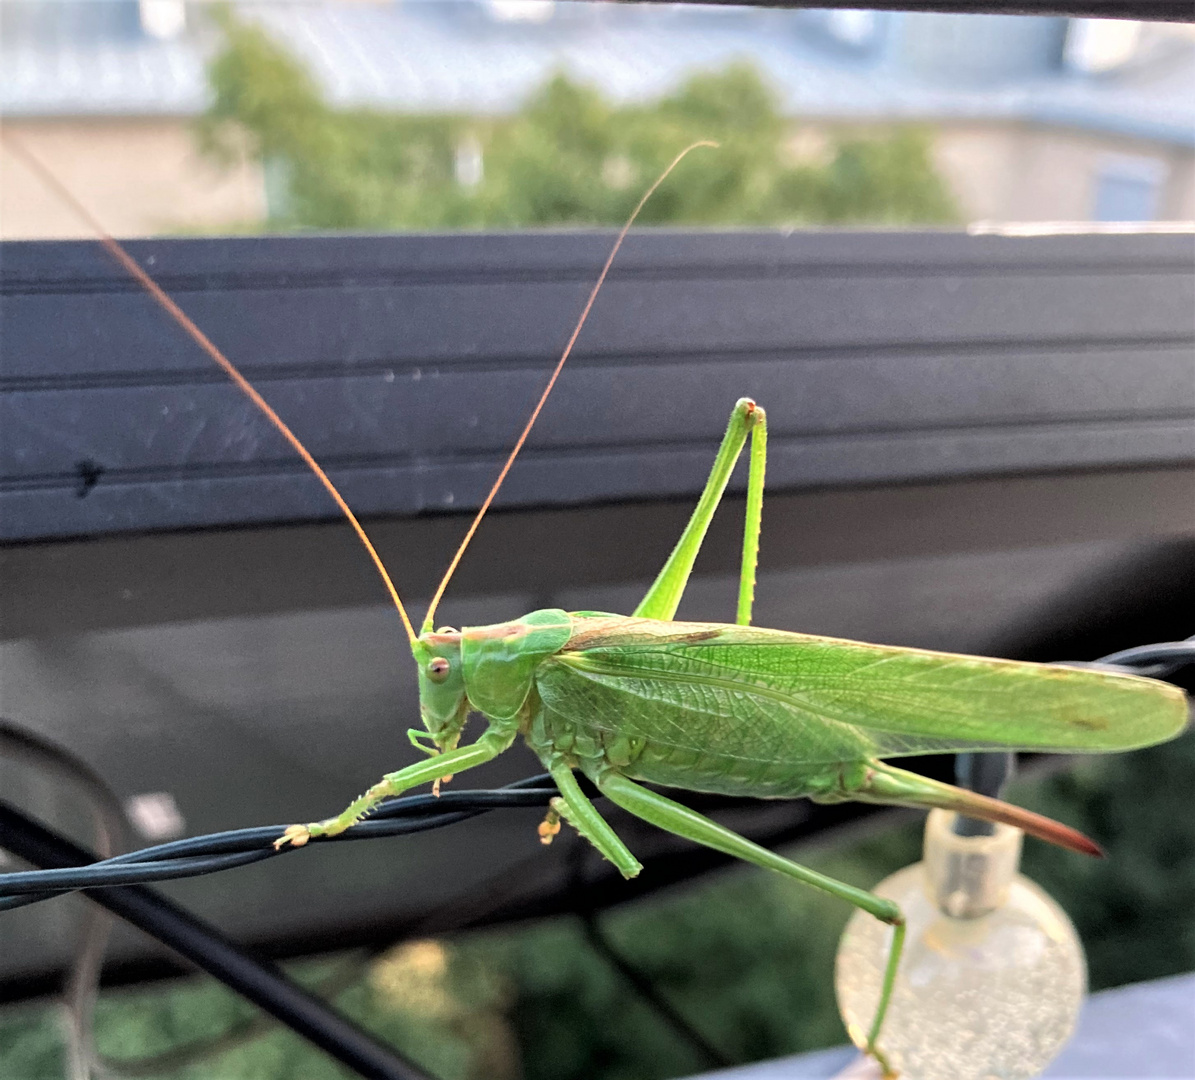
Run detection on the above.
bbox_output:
[924,810,1023,919]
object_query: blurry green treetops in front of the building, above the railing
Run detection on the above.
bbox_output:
[200,11,957,229]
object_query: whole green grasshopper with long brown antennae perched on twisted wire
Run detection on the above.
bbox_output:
[16,143,1187,1076]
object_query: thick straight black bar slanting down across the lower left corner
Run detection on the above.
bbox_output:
[0,802,427,1080]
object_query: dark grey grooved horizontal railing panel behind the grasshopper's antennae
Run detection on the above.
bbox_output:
[0,231,1195,540]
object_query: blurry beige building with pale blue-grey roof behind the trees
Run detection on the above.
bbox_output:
[0,0,1195,239]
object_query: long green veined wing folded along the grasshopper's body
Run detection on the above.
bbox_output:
[537,618,1187,788]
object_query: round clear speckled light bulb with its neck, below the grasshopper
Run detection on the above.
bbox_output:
[834,810,1087,1080]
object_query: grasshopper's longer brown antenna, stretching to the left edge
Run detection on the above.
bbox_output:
[4,131,417,644]
